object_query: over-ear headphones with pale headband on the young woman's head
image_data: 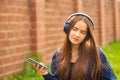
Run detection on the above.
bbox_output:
[64,13,94,34]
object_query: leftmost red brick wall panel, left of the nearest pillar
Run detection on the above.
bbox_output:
[0,0,31,76]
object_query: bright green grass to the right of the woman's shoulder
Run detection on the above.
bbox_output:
[103,41,120,80]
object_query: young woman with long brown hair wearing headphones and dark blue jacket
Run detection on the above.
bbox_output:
[35,13,117,80]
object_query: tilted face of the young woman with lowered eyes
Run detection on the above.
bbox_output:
[69,21,87,46]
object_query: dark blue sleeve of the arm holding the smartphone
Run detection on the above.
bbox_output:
[43,52,60,80]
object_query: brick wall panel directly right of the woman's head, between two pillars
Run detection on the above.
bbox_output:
[82,0,101,44]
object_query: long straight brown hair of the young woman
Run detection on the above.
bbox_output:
[58,16,102,80]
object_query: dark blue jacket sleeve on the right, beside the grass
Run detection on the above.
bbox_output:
[99,48,117,80]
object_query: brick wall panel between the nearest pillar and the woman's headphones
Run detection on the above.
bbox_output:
[44,0,74,61]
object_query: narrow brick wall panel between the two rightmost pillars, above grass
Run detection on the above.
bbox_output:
[104,0,115,45]
